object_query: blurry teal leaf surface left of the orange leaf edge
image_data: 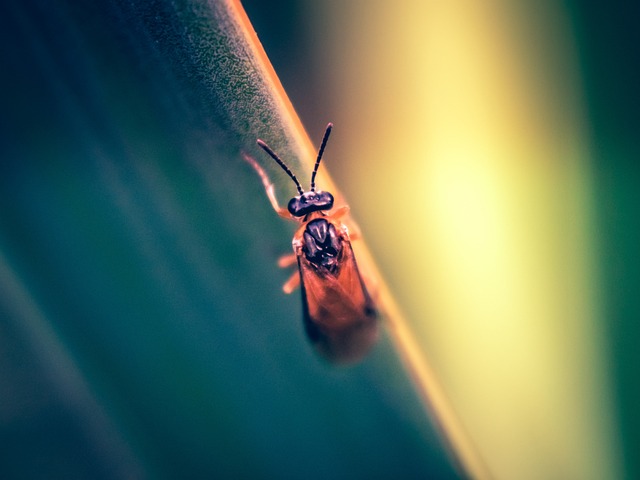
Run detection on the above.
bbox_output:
[0,1,458,479]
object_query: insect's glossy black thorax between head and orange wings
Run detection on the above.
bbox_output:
[302,218,342,273]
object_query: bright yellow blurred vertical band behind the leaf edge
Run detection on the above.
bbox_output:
[322,1,620,479]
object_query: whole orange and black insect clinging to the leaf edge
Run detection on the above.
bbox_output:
[245,123,378,363]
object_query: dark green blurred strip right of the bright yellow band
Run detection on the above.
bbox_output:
[569,1,640,478]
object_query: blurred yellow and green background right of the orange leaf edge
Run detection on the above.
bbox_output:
[245,0,640,478]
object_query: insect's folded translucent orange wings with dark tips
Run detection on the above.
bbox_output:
[296,234,378,363]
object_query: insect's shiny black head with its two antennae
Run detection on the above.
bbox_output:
[258,123,333,217]
